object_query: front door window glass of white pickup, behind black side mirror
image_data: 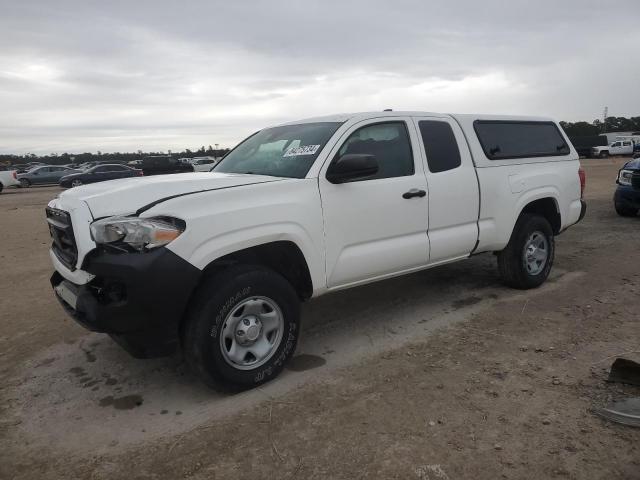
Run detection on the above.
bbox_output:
[336,122,414,180]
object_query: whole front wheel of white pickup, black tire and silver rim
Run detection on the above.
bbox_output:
[183,265,300,389]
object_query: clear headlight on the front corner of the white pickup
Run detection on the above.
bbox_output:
[91,216,185,252]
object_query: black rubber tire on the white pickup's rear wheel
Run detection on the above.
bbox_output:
[498,213,555,290]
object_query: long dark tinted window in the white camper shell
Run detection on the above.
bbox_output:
[473,120,569,160]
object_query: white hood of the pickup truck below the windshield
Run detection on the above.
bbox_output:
[55,172,284,219]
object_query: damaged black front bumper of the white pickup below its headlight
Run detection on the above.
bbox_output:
[51,248,201,357]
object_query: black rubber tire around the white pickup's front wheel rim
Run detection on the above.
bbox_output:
[182,265,300,389]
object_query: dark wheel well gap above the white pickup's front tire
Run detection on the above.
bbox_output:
[203,240,313,300]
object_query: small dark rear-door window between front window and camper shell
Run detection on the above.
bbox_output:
[418,120,460,173]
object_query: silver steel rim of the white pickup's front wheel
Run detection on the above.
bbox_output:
[220,297,284,370]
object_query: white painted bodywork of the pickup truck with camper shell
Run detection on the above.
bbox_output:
[50,112,581,296]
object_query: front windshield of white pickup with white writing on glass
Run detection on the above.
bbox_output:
[213,122,342,178]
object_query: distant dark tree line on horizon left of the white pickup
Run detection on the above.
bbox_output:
[0,145,229,165]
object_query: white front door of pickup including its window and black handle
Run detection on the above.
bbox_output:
[319,117,429,288]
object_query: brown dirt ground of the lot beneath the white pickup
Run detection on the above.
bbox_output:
[0,158,640,480]
